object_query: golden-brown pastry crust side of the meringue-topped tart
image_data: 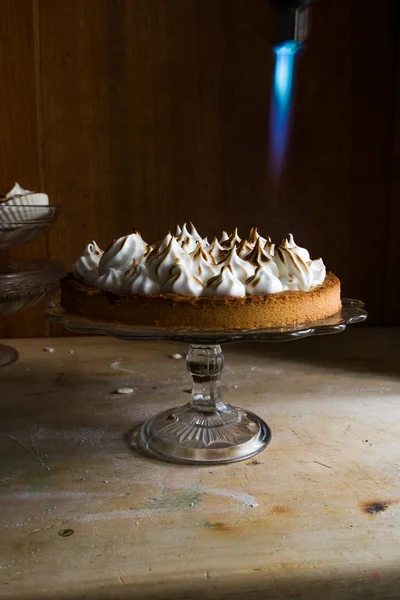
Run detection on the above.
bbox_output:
[61,273,341,330]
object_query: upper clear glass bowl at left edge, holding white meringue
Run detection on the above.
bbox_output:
[0,204,59,250]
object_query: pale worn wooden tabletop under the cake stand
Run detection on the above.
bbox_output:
[0,327,400,600]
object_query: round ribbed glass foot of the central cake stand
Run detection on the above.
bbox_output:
[138,403,271,465]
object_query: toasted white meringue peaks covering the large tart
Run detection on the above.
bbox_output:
[72,227,326,297]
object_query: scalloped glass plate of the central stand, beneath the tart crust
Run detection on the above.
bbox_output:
[45,298,368,344]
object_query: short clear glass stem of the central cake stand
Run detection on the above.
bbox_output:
[186,344,228,413]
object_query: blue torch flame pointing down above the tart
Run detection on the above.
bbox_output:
[270,40,300,178]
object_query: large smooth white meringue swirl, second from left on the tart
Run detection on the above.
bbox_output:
[99,231,147,275]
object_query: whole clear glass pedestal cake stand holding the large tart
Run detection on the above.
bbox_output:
[45,298,367,465]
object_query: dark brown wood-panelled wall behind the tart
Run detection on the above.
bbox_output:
[0,0,400,337]
